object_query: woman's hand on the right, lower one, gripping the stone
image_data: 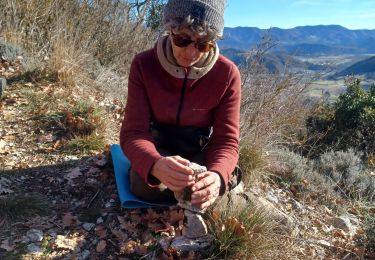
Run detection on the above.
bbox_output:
[191,171,221,209]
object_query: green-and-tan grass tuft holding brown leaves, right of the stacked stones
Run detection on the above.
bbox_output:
[205,205,275,259]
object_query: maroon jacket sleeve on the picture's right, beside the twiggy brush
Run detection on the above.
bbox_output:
[207,64,241,188]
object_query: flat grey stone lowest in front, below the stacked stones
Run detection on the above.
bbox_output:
[171,235,214,252]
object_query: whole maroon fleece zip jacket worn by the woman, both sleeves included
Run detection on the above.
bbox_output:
[120,47,241,189]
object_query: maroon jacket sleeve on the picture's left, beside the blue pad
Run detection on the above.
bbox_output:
[120,57,161,185]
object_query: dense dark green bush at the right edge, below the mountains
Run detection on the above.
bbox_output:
[306,77,375,156]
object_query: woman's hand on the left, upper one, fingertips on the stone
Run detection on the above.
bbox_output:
[151,156,195,192]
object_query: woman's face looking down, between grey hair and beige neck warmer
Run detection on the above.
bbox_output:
[170,29,212,68]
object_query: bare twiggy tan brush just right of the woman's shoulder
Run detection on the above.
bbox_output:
[240,37,312,149]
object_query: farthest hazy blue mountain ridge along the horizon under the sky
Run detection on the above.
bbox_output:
[219,25,375,56]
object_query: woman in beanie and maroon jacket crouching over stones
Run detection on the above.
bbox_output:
[120,0,241,209]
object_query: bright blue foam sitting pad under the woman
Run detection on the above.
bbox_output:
[111,144,173,209]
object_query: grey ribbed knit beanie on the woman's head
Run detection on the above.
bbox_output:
[164,0,225,34]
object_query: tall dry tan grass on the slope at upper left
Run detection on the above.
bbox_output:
[0,0,156,97]
